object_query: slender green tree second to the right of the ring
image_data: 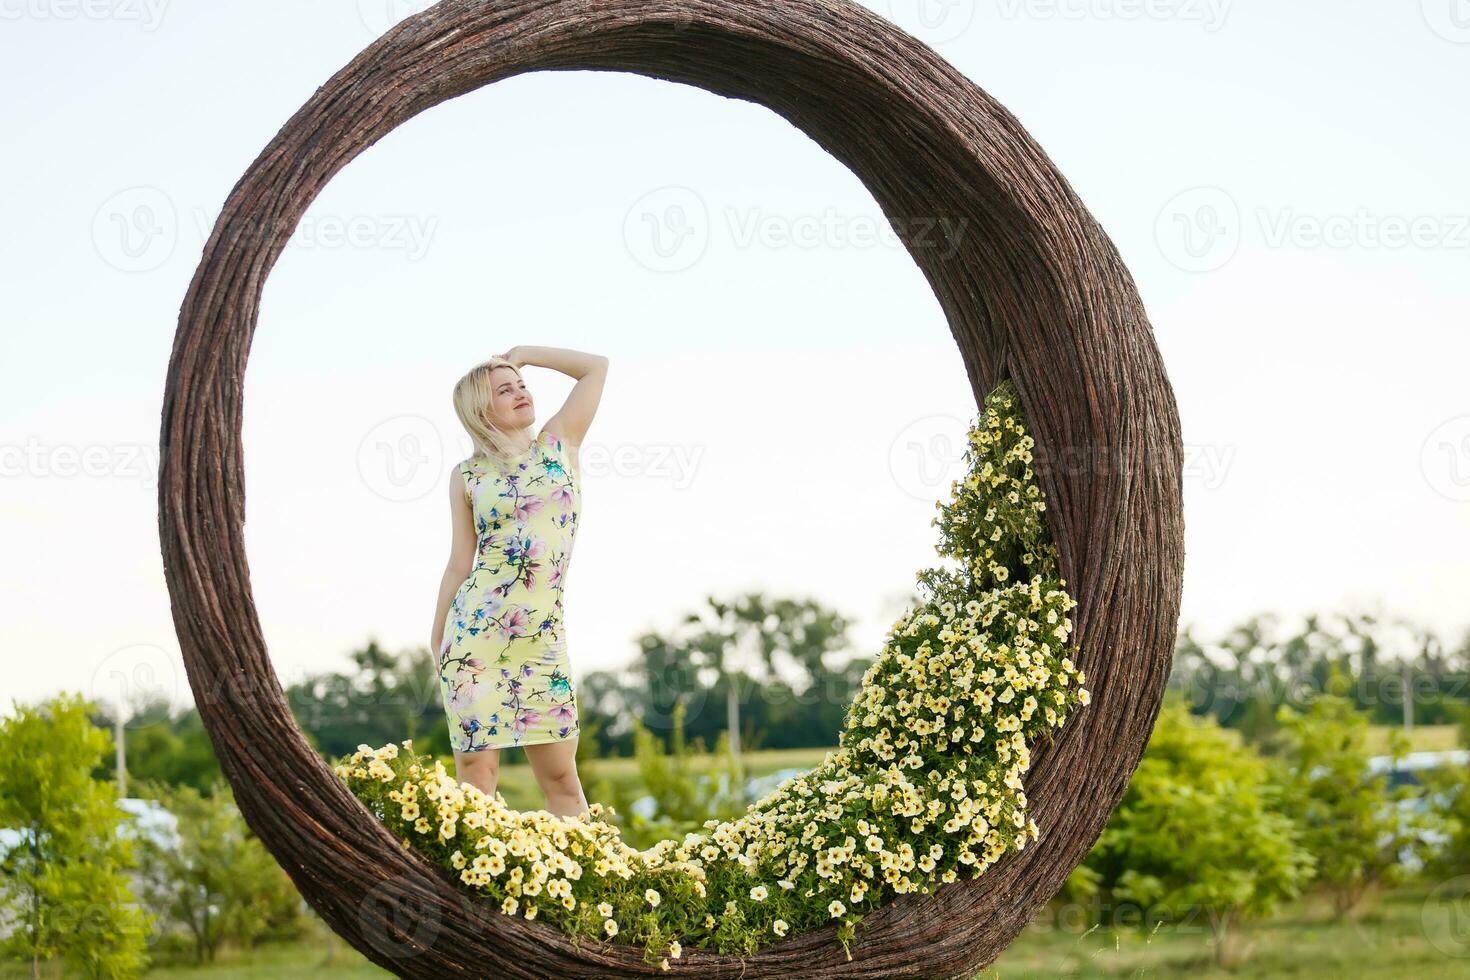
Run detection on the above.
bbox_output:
[1270,667,1414,918]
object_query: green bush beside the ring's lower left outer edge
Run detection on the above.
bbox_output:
[131,782,306,964]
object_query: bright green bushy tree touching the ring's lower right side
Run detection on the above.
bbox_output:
[1088,701,1313,965]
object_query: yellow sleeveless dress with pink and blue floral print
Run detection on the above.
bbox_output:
[438,429,582,752]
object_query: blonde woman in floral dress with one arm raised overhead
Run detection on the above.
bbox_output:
[431,347,607,817]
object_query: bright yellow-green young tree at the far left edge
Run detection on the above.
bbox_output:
[0,693,148,979]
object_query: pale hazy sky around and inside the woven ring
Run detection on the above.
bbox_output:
[0,0,1470,711]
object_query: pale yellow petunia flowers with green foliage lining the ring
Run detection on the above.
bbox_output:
[335,382,1088,968]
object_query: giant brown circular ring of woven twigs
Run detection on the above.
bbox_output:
[159,0,1183,979]
